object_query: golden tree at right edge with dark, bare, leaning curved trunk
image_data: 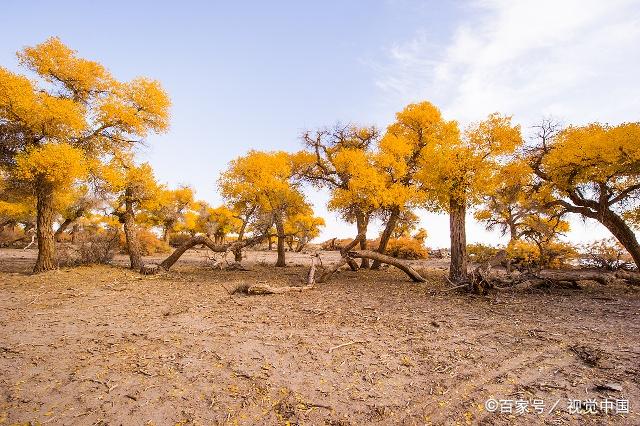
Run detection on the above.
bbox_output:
[526,120,640,266]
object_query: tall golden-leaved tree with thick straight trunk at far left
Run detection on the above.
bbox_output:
[0,38,170,272]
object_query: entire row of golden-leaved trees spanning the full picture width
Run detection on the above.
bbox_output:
[0,38,640,282]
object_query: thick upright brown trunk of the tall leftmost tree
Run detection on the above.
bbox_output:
[33,182,56,273]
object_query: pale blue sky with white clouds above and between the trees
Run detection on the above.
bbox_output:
[0,0,640,246]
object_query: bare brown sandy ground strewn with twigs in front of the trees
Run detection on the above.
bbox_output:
[0,250,640,425]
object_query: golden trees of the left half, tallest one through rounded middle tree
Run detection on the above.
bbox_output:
[0,38,324,272]
